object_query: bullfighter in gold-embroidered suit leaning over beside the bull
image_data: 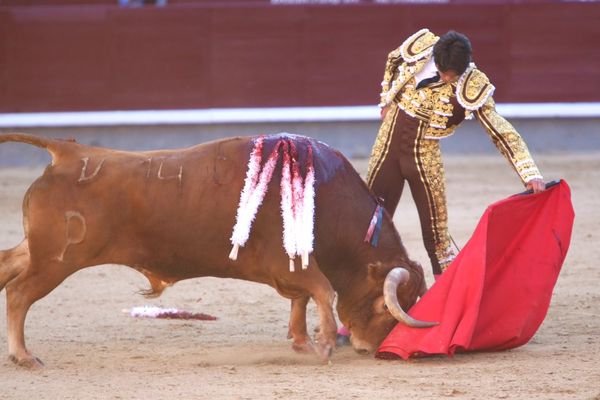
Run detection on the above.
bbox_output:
[367,29,545,279]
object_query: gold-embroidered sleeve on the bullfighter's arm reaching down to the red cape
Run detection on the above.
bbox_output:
[474,96,543,184]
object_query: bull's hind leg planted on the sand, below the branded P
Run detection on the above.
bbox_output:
[6,260,70,368]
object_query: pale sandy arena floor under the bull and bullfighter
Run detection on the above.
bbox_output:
[0,154,600,400]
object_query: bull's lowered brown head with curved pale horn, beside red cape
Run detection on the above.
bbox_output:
[338,262,437,354]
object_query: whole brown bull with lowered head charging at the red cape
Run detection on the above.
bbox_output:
[0,134,427,367]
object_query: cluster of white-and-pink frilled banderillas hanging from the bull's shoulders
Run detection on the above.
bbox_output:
[229,136,315,271]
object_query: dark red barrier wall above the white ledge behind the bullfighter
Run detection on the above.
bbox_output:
[0,0,600,112]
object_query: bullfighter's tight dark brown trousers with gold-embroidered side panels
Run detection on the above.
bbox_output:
[367,105,455,274]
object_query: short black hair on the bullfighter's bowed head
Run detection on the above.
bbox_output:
[433,31,471,75]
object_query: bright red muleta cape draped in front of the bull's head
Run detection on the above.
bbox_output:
[376,180,575,359]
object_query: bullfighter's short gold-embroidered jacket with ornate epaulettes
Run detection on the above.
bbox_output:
[379,29,542,183]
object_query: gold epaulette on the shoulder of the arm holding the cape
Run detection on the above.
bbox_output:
[456,63,496,111]
